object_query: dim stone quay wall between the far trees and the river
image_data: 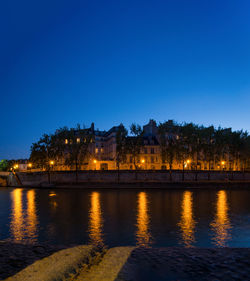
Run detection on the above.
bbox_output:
[12,170,250,186]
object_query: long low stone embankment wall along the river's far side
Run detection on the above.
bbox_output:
[7,170,250,187]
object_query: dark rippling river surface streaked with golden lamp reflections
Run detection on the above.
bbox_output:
[0,188,250,247]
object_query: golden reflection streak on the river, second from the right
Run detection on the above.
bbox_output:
[178,191,195,247]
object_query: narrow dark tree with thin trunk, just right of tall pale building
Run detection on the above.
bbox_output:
[116,124,128,182]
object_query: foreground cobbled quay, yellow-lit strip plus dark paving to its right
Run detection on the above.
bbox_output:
[6,245,250,281]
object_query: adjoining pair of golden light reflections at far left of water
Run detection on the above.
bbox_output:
[10,188,38,242]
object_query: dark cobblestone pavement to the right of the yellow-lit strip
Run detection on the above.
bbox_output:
[115,248,250,281]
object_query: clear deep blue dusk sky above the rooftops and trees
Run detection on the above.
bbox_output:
[0,0,250,159]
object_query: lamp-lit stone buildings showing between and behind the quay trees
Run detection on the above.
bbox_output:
[51,119,245,170]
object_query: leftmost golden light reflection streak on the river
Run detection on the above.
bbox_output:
[10,188,25,242]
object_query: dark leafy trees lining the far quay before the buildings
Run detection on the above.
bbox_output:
[30,120,250,178]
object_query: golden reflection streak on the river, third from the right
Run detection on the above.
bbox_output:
[136,192,151,247]
